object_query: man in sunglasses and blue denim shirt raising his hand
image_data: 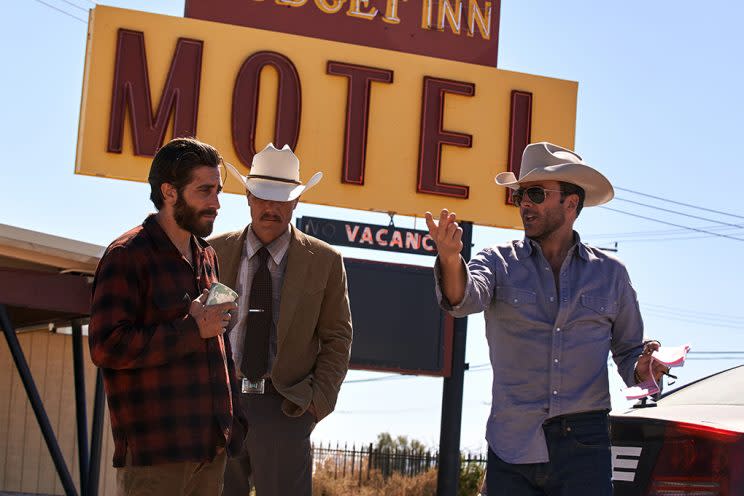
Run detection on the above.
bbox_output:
[426,143,667,496]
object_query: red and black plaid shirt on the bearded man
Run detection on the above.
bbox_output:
[89,216,242,467]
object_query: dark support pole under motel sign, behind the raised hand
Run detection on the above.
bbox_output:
[437,222,473,496]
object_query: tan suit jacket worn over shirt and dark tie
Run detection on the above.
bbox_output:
[209,226,352,420]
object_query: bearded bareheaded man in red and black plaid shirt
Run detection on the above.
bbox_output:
[89,138,245,496]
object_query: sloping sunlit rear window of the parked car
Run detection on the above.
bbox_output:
[659,365,744,406]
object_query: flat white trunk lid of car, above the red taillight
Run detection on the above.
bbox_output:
[610,402,744,433]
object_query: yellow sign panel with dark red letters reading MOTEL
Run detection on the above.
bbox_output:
[75,6,577,227]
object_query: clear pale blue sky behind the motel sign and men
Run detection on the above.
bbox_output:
[0,0,744,452]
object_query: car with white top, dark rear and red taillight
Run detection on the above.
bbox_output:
[610,365,744,496]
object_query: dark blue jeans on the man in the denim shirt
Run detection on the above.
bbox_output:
[486,412,612,496]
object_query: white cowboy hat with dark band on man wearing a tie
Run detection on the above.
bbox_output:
[225,143,323,201]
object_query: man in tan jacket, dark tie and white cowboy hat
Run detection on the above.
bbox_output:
[210,144,352,496]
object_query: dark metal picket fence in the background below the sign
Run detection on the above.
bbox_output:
[312,443,486,484]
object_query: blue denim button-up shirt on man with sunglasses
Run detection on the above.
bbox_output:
[435,233,643,463]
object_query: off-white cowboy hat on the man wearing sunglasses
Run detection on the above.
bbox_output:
[495,141,615,207]
